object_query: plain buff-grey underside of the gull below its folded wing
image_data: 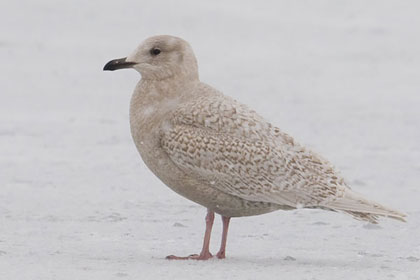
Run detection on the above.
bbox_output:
[134,137,287,217]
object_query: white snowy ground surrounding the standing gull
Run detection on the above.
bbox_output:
[0,0,420,280]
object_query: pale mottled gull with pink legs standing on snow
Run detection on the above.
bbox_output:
[103,35,406,260]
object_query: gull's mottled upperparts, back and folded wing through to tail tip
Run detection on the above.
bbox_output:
[161,91,405,221]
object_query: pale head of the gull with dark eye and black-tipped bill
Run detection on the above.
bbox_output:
[104,35,198,80]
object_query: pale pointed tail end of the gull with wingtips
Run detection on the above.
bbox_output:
[326,190,406,224]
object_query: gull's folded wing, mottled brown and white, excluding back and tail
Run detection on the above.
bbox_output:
[161,122,339,207]
